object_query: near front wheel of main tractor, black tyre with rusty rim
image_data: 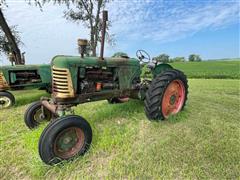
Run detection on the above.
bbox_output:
[38,115,92,165]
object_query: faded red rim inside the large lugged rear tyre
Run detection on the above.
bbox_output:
[162,80,185,118]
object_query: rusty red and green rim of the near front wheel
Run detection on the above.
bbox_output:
[54,127,85,159]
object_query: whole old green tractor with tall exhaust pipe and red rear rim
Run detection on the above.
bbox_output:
[24,11,188,165]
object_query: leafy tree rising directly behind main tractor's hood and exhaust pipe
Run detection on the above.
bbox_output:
[65,0,113,56]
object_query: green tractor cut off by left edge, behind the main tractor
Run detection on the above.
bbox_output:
[0,65,51,109]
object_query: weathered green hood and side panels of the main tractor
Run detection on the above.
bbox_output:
[52,56,141,91]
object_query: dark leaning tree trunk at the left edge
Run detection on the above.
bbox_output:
[0,8,24,64]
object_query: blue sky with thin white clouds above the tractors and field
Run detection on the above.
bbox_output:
[0,0,240,64]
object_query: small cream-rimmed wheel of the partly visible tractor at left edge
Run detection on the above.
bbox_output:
[0,91,15,109]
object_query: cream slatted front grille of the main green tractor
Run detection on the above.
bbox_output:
[52,67,74,98]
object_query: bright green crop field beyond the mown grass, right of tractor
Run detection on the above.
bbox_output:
[171,59,240,79]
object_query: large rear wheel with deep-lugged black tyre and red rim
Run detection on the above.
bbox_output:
[144,69,188,120]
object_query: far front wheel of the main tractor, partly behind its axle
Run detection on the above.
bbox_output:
[24,101,52,129]
